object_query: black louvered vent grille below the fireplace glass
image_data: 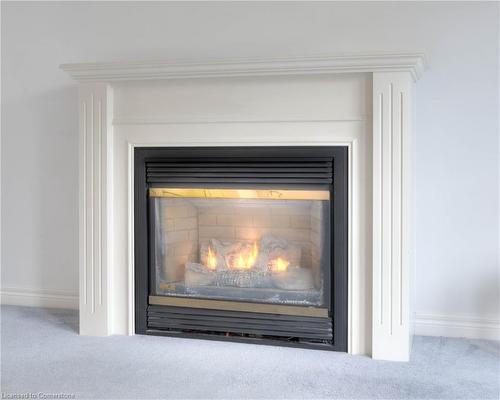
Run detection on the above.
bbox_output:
[147,305,333,341]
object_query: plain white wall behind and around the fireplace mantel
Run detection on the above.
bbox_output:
[1,2,500,336]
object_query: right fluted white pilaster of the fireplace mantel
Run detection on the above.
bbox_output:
[372,72,415,361]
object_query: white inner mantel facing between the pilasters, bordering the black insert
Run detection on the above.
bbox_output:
[110,126,371,354]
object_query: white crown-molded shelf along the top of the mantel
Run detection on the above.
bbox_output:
[60,53,427,82]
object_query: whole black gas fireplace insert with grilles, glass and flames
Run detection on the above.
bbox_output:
[134,146,348,352]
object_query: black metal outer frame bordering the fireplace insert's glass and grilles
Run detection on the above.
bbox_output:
[134,146,348,352]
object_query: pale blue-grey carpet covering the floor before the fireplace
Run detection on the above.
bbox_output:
[1,306,500,399]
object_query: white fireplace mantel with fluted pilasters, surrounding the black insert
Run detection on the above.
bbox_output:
[61,54,425,360]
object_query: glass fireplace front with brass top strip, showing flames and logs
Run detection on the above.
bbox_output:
[149,187,331,315]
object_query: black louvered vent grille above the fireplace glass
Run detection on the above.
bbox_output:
[146,157,333,185]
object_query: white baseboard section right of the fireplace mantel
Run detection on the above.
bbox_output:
[415,313,500,340]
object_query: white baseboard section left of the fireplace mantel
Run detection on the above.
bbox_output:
[0,287,78,310]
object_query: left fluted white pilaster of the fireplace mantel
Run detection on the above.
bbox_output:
[78,83,113,336]
